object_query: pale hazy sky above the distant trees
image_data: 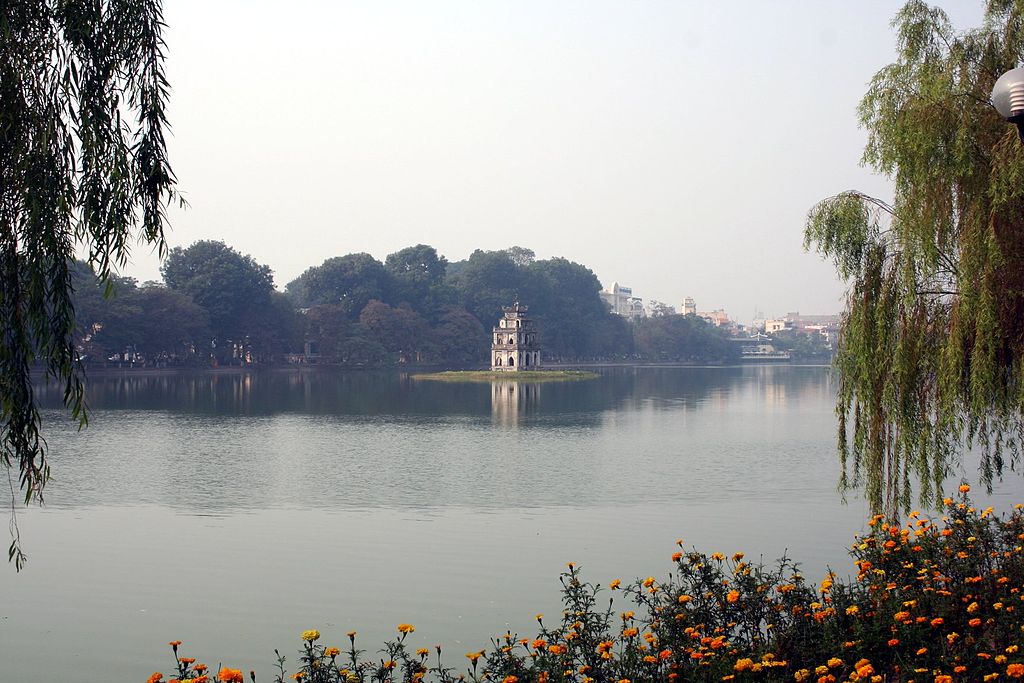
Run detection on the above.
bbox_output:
[117,0,982,322]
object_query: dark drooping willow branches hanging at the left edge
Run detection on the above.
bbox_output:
[0,0,175,568]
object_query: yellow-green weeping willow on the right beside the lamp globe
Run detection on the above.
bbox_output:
[805,0,1024,515]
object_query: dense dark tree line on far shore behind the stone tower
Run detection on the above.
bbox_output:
[73,241,737,367]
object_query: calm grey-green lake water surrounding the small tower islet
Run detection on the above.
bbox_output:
[0,366,1024,681]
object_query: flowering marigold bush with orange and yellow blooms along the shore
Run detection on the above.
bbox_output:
[151,485,1024,683]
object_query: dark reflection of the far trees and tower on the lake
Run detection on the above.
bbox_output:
[37,366,833,425]
